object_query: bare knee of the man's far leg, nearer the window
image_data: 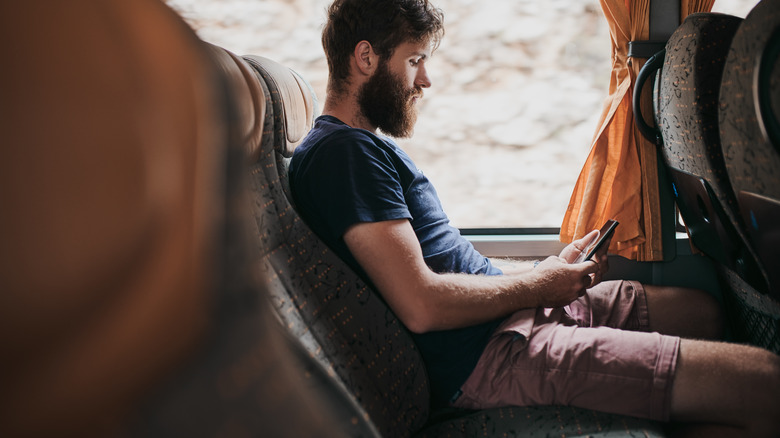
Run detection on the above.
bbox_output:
[644,285,723,339]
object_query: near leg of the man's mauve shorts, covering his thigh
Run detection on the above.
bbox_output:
[455,302,680,420]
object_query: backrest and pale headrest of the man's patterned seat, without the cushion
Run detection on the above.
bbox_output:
[245,57,429,436]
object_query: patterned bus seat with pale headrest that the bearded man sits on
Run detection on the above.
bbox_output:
[243,51,663,437]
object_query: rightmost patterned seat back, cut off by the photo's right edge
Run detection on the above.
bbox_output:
[718,0,780,352]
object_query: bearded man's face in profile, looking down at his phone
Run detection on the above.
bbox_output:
[358,43,430,137]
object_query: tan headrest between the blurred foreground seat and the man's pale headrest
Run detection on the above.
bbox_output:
[205,43,266,162]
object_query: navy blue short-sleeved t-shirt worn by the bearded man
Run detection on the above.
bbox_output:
[289,116,502,406]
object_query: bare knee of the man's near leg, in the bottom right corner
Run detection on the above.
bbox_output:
[671,339,780,437]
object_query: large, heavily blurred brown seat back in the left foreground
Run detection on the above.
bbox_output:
[0,0,223,436]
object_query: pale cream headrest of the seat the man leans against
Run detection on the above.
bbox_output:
[244,56,317,157]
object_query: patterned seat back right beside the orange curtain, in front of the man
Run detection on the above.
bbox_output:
[642,13,767,290]
